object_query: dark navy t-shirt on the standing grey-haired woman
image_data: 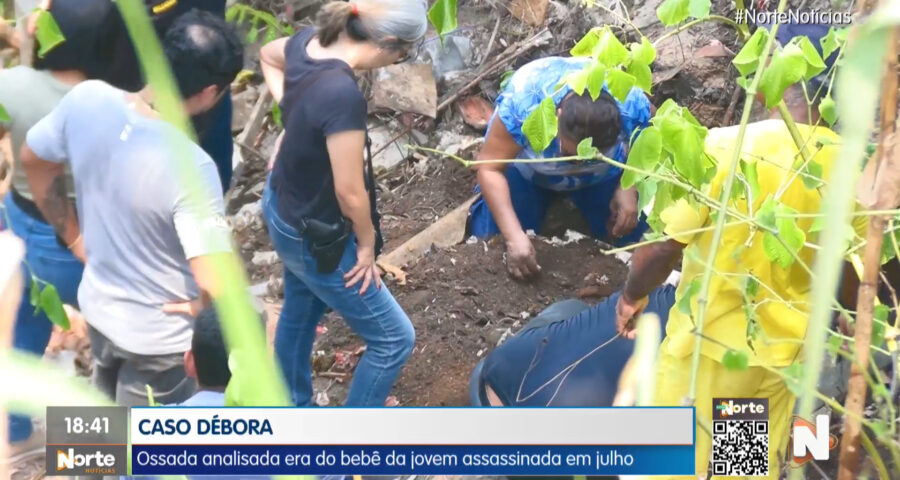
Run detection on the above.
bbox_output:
[271,28,366,229]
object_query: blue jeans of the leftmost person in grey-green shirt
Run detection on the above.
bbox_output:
[0,194,84,442]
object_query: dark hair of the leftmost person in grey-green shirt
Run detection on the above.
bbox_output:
[34,0,116,74]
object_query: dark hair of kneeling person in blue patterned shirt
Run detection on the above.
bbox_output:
[559,90,622,150]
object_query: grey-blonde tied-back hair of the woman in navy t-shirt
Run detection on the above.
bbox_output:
[316,0,428,47]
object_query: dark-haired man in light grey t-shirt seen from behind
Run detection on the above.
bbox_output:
[22,11,243,405]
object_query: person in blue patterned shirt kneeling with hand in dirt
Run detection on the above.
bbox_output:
[469,57,651,279]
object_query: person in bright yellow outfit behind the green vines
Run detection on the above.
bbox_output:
[616,111,860,478]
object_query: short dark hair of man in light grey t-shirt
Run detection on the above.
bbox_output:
[163,9,244,98]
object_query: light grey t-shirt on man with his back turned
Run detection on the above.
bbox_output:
[27,81,231,355]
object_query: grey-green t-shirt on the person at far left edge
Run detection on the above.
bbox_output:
[0,66,75,199]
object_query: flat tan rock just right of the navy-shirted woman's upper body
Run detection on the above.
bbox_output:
[371,63,437,118]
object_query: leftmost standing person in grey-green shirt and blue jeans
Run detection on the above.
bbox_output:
[0,0,109,456]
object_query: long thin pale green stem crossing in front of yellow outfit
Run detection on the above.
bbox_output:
[685,0,787,405]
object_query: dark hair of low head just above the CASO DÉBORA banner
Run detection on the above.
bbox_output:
[191,307,231,387]
